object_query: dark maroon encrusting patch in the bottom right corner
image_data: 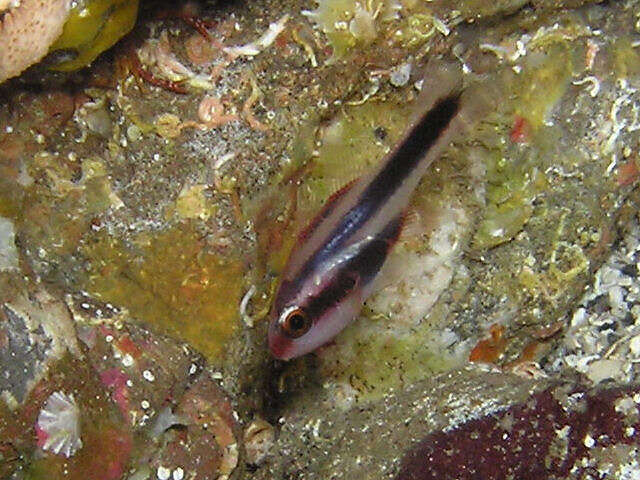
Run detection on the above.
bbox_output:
[396,382,640,480]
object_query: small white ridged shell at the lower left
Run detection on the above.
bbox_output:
[36,391,82,458]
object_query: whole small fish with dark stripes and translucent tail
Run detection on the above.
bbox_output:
[268,67,483,360]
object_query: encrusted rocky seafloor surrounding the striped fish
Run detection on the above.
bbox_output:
[0,0,640,480]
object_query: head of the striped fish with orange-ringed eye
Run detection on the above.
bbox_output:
[268,277,362,360]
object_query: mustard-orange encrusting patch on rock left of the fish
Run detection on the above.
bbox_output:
[77,222,244,358]
